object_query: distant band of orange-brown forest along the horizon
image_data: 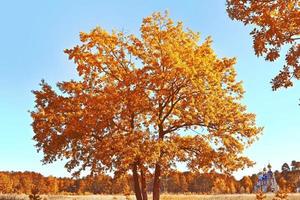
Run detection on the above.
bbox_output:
[0,162,300,194]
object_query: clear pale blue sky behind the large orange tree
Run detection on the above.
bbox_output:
[0,0,300,178]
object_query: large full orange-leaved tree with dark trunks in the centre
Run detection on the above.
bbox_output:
[31,13,261,200]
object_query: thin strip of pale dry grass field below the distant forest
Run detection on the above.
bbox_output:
[0,194,300,200]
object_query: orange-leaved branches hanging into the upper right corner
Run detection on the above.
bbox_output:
[227,0,300,90]
